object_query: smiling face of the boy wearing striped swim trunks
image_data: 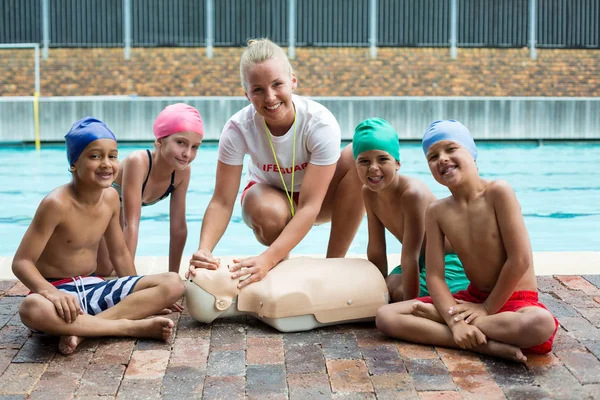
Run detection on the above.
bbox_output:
[72,139,119,188]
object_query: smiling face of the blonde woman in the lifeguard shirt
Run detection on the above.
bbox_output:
[244,58,296,131]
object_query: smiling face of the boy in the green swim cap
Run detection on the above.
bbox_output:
[356,150,400,192]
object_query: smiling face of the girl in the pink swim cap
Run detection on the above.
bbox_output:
[156,132,202,171]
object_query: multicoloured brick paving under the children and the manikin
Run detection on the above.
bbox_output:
[0,275,600,400]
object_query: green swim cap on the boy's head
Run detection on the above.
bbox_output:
[352,118,400,161]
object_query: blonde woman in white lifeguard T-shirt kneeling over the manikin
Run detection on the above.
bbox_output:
[190,39,364,287]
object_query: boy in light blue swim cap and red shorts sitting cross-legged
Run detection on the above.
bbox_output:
[376,120,558,362]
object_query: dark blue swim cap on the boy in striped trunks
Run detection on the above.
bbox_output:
[65,117,117,165]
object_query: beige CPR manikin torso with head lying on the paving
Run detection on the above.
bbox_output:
[185,257,388,332]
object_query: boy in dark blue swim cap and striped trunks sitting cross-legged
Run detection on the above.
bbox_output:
[12,117,184,354]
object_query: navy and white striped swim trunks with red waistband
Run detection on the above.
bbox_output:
[48,276,143,315]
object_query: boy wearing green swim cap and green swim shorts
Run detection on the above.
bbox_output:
[352,118,469,302]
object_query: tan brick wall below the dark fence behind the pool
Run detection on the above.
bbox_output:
[0,48,600,97]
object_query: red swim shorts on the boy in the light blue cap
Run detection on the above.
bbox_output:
[416,284,558,354]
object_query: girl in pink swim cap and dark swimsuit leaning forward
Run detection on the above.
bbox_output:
[96,103,204,276]
